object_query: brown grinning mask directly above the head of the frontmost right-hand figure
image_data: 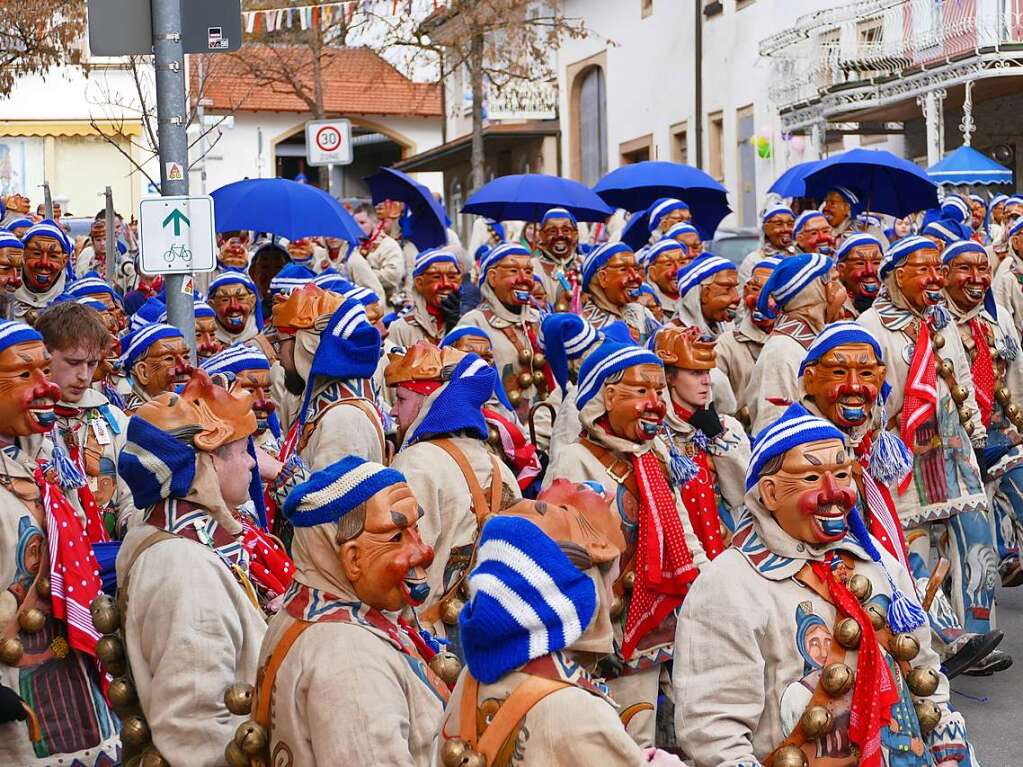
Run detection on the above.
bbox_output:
[803,344,887,430]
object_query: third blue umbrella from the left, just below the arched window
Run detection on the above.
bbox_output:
[461,173,614,221]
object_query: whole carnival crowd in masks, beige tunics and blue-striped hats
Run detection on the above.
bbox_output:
[0,173,1023,767]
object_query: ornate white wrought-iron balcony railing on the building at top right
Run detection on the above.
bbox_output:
[760,0,1023,109]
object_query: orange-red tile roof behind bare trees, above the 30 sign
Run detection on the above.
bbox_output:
[189,44,441,118]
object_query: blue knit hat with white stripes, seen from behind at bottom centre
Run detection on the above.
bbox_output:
[458,514,596,684]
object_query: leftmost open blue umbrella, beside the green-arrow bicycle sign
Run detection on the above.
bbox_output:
[212,178,365,245]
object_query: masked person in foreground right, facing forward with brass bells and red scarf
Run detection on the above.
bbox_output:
[672,411,974,767]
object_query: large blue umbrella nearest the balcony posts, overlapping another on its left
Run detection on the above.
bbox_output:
[805,148,938,218]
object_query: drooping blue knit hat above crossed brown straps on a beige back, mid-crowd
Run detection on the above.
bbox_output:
[405,354,497,445]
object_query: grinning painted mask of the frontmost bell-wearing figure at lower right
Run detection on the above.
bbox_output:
[757,440,856,546]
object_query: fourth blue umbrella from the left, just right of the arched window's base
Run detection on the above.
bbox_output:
[593,160,731,239]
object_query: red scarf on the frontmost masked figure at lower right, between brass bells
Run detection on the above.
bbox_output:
[810,552,898,767]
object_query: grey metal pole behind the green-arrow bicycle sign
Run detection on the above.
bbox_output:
[151,0,195,362]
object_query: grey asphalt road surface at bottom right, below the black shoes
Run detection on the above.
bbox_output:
[951,586,1023,767]
